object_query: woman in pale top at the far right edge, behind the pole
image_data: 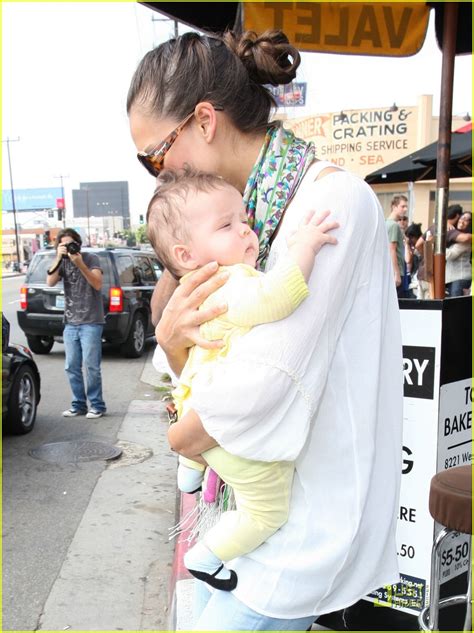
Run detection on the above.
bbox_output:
[446,213,472,297]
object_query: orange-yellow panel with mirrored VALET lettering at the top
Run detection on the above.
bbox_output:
[242,2,430,57]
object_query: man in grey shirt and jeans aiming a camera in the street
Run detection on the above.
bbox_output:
[46,228,106,419]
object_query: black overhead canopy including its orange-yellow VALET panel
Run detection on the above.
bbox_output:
[140,2,472,57]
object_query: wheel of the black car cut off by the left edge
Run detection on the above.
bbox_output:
[6,365,39,435]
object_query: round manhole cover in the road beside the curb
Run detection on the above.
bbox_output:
[28,440,122,464]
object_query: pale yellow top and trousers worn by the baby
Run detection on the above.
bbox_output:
[172,257,308,561]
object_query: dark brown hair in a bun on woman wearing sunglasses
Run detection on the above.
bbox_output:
[127,31,300,132]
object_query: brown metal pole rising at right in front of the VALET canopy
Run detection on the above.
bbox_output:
[433,2,459,299]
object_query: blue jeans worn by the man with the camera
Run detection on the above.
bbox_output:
[63,323,106,412]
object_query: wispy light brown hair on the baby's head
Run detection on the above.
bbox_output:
[146,166,230,279]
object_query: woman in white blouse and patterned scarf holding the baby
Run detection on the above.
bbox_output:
[127,31,402,630]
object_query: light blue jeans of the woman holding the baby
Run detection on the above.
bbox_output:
[194,580,316,631]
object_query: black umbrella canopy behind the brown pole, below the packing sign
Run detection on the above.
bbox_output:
[365,131,472,185]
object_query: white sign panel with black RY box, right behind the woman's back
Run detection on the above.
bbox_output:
[367,310,442,615]
